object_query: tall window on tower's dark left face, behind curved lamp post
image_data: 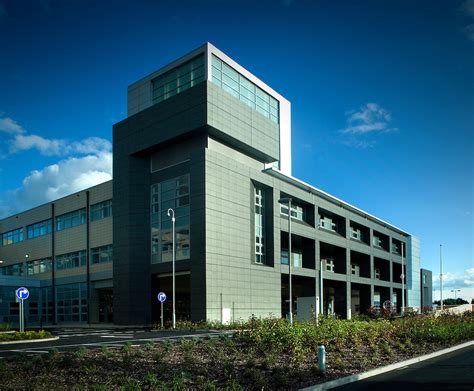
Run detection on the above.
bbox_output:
[151,175,190,263]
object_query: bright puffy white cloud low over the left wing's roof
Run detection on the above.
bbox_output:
[0,151,112,217]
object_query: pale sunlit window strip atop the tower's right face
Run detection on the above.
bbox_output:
[212,55,280,124]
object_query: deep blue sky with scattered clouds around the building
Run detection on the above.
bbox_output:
[0,0,474,298]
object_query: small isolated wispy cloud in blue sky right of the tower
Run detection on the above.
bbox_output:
[341,102,395,135]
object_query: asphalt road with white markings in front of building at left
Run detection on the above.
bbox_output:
[0,329,229,359]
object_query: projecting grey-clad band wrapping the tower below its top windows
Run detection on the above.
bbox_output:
[113,82,280,162]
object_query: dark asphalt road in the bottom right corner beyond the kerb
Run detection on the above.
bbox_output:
[334,346,474,391]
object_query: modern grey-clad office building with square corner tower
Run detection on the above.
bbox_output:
[0,43,420,325]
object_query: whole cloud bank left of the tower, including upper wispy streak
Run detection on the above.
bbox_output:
[0,117,112,218]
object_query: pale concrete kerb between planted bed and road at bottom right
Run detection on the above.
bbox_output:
[300,341,474,391]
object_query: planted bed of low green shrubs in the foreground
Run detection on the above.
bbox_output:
[0,313,474,390]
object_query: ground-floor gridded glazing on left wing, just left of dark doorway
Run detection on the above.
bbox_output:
[56,282,87,322]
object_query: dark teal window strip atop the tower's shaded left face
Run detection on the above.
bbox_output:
[152,55,204,103]
